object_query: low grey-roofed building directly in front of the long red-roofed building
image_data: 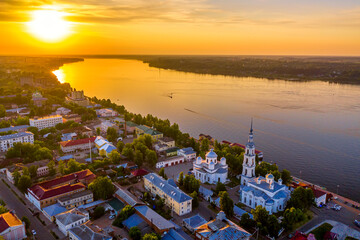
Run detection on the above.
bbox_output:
[58,190,94,209]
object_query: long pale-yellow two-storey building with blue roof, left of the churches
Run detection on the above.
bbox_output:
[143,173,192,216]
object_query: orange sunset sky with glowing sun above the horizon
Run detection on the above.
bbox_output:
[0,0,360,56]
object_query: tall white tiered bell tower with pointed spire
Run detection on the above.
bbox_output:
[241,118,256,185]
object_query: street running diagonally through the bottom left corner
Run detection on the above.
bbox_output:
[0,180,55,240]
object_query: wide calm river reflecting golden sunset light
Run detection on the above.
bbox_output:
[56,59,360,201]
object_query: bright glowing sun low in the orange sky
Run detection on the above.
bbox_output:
[27,10,71,42]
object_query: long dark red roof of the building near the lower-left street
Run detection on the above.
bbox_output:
[28,169,96,200]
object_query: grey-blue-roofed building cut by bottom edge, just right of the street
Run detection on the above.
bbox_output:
[69,221,113,240]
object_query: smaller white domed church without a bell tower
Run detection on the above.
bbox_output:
[193,149,228,184]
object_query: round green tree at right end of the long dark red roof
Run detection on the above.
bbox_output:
[89,177,115,199]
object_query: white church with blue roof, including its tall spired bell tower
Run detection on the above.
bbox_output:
[239,122,290,214]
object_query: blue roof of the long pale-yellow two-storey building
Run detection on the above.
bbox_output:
[144,173,192,203]
